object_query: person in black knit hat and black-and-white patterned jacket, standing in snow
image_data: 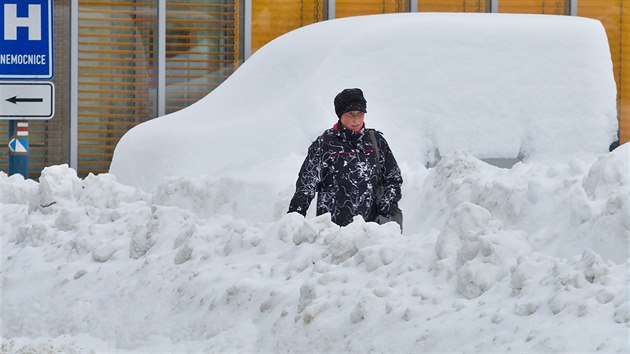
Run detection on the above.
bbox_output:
[288,88,403,230]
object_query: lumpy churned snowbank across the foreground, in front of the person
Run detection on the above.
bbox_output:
[0,144,630,353]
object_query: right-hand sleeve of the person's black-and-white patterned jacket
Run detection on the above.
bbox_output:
[378,132,403,217]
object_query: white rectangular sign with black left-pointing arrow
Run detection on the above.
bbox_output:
[0,81,55,120]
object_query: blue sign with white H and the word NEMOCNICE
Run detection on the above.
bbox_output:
[0,0,54,79]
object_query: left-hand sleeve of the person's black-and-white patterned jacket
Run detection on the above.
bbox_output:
[288,139,322,216]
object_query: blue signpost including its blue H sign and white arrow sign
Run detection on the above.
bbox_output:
[0,0,55,178]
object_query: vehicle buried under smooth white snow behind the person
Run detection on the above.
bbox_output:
[110,13,617,190]
